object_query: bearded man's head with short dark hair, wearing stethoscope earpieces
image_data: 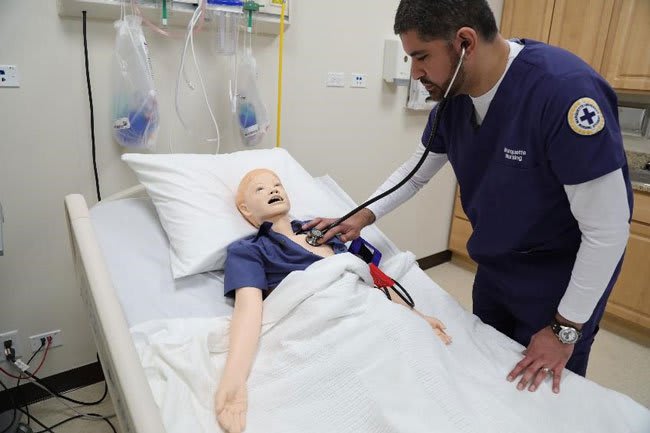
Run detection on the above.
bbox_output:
[394,0,498,101]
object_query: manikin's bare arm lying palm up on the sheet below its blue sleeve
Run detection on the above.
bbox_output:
[215,287,262,433]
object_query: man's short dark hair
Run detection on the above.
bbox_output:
[394,0,498,42]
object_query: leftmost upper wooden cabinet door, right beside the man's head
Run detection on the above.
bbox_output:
[500,0,555,42]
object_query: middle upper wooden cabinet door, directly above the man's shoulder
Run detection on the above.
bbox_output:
[548,0,614,71]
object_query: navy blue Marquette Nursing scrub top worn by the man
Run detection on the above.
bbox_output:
[422,40,632,290]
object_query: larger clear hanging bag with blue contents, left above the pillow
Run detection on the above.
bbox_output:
[112,15,159,149]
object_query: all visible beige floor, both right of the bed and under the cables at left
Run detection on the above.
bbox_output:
[15,263,650,433]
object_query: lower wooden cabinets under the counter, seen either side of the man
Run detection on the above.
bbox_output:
[449,187,650,336]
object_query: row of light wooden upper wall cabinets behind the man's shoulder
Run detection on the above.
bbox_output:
[501,0,650,93]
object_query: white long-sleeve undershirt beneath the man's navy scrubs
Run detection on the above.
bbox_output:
[368,42,630,323]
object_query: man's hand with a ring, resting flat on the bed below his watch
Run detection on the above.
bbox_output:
[508,326,573,394]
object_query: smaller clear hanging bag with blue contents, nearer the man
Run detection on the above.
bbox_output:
[236,54,270,146]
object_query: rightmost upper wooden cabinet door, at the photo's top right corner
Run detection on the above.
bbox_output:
[601,0,650,91]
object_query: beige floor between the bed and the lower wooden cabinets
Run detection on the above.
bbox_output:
[426,262,650,408]
